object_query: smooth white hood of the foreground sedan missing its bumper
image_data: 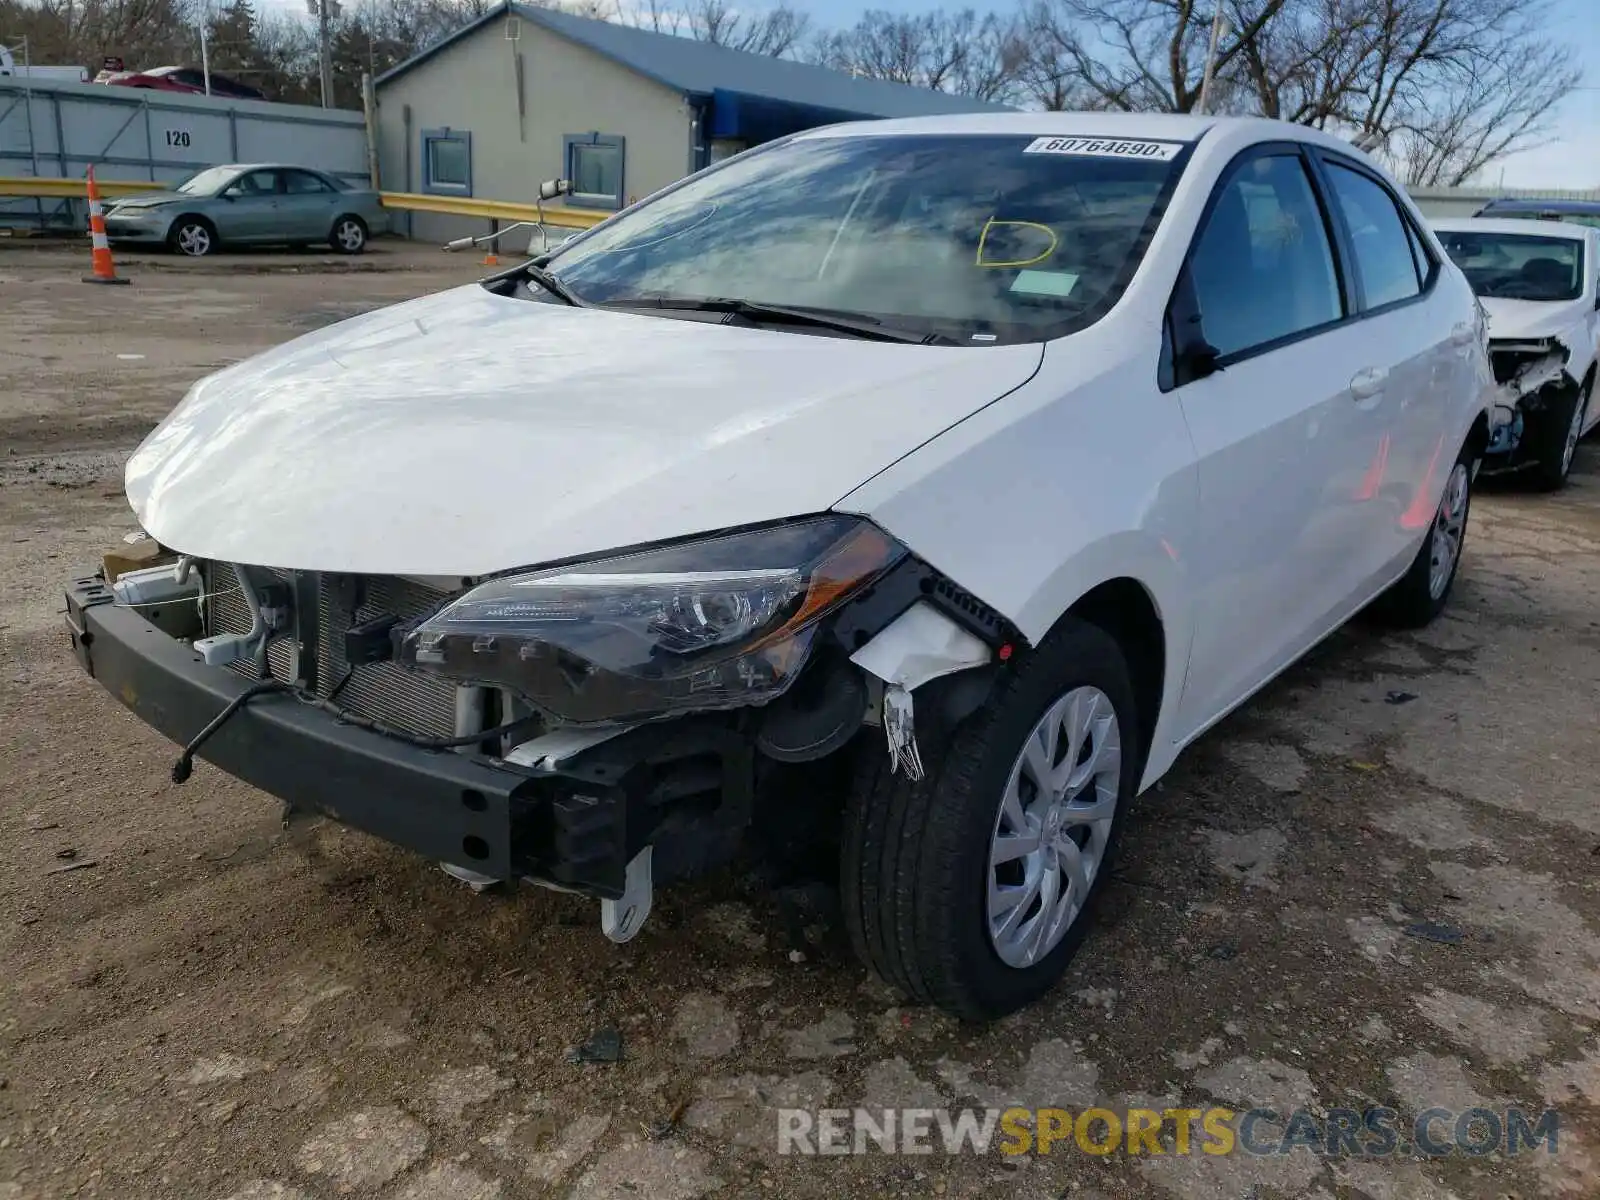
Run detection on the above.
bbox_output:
[126,285,1042,576]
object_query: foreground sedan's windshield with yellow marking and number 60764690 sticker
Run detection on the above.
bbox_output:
[549,134,1184,344]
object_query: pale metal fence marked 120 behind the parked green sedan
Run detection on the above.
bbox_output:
[0,77,368,226]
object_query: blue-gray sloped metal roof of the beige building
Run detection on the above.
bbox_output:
[378,3,1006,117]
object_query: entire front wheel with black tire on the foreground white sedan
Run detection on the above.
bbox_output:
[842,618,1142,1021]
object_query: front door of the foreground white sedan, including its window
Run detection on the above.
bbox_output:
[1168,142,1382,730]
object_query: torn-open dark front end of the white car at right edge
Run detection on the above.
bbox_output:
[1483,338,1582,472]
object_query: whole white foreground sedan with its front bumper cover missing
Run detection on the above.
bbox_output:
[67,114,1493,1019]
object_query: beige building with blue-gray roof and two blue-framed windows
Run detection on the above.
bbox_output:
[376,3,1000,245]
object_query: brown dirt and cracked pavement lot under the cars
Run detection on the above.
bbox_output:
[0,246,1600,1200]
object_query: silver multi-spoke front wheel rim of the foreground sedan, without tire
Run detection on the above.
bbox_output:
[987,686,1122,968]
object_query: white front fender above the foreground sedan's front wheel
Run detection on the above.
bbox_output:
[835,339,1198,790]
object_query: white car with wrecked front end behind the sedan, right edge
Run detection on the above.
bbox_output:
[1434,218,1600,490]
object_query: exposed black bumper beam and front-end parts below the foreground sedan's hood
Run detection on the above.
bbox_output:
[67,531,1021,941]
